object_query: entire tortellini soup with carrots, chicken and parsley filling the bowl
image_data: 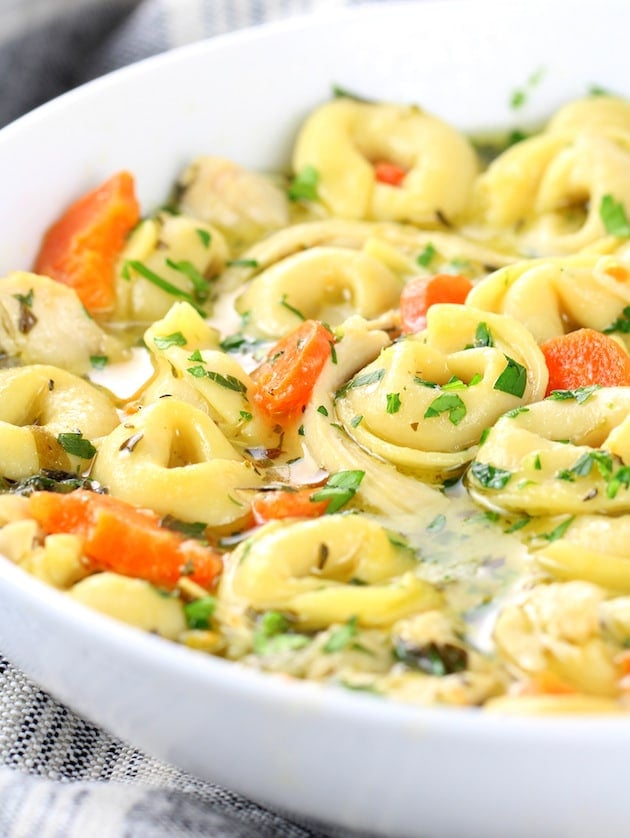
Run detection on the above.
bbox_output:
[0,94,630,713]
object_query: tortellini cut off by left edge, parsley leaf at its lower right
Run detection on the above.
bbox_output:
[0,364,118,480]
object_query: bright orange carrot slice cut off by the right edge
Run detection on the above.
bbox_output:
[540,329,630,395]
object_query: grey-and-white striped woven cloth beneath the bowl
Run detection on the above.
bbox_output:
[0,0,388,838]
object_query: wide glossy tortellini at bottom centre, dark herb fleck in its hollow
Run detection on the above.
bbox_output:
[220,515,441,629]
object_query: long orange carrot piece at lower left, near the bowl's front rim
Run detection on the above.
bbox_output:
[29,489,222,588]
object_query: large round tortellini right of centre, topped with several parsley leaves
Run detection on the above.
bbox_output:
[335,304,547,482]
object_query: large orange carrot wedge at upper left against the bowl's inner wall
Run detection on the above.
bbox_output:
[34,171,140,313]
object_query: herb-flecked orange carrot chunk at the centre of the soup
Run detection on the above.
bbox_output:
[251,320,335,421]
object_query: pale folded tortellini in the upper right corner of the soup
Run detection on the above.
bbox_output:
[472,98,630,256]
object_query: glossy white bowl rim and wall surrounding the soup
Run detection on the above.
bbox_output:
[0,0,630,838]
